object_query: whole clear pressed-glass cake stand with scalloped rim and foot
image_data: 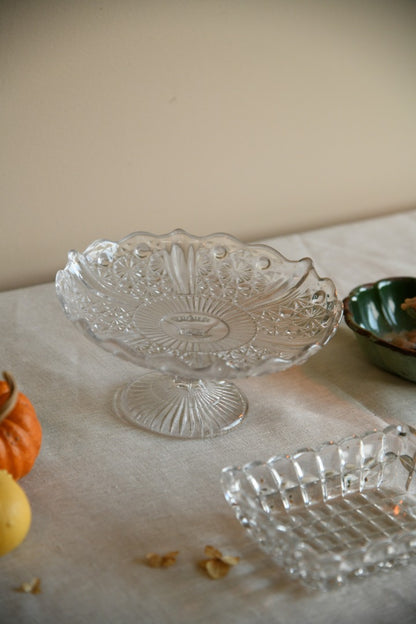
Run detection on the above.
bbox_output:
[56,230,342,438]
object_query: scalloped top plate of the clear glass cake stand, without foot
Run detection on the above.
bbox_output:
[56,229,342,379]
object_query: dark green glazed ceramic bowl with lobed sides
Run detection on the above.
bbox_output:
[343,277,416,382]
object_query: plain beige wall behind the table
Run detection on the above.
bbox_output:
[0,0,416,289]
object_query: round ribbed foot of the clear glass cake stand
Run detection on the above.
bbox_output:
[113,373,248,438]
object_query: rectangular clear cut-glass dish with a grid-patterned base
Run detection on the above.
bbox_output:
[221,425,416,589]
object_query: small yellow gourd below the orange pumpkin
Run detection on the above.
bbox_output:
[0,470,32,557]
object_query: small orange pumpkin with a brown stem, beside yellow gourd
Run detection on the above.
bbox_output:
[0,372,42,480]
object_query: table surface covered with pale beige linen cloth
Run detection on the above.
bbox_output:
[0,210,416,624]
